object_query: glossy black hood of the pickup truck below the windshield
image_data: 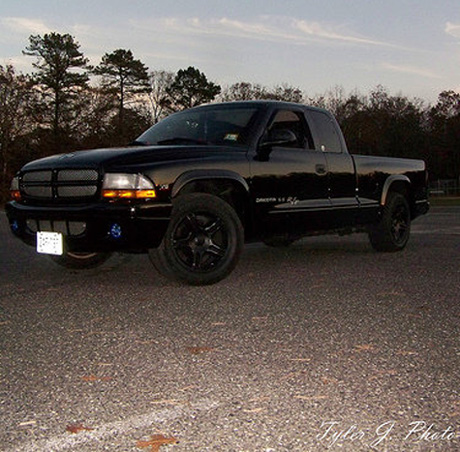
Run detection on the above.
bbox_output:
[21,146,247,171]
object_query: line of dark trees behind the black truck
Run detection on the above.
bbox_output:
[0,32,460,200]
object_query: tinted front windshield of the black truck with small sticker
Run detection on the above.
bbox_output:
[136,107,257,146]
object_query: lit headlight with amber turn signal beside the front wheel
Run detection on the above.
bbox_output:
[102,173,156,199]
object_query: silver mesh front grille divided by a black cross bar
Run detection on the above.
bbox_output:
[20,169,99,201]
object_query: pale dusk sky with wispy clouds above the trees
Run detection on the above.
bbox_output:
[0,0,460,103]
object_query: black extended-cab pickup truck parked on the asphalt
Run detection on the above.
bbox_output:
[6,101,429,284]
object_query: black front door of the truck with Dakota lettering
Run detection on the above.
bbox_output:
[251,108,331,236]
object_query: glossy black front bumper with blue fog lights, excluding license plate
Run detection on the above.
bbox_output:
[6,201,172,252]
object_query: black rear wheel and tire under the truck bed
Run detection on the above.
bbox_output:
[369,193,411,252]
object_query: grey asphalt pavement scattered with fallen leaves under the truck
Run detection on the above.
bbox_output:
[0,207,460,452]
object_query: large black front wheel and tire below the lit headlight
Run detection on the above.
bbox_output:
[149,193,244,285]
